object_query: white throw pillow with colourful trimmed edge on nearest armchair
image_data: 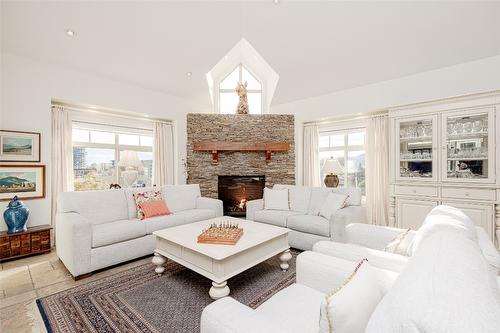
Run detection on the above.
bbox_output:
[319,258,383,333]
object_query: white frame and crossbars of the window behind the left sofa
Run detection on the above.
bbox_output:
[71,121,154,184]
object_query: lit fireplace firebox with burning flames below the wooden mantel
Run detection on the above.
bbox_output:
[218,176,266,216]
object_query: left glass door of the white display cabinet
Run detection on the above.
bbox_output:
[397,116,436,180]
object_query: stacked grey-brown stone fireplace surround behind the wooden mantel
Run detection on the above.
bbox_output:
[186,113,295,198]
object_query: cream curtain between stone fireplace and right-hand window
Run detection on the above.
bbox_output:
[303,125,321,186]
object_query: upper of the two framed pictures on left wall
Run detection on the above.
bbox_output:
[0,130,40,162]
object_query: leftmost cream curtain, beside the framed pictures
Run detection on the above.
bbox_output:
[50,105,73,239]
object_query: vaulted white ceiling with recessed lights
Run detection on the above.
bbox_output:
[1,0,500,105]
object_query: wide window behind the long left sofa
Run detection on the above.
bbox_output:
[73,122,153,191]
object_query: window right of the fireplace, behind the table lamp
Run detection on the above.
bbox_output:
[319,128,365,195]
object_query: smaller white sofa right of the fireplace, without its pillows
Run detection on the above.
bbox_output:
[246,184,367,250]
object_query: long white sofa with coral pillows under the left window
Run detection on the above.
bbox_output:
[56,184,222,277]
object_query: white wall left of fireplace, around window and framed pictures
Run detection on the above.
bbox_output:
[0,53,205,230]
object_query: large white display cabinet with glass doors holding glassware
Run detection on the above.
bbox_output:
[389,92,500,246]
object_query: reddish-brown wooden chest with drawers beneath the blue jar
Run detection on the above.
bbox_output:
[0,225,52,261]
